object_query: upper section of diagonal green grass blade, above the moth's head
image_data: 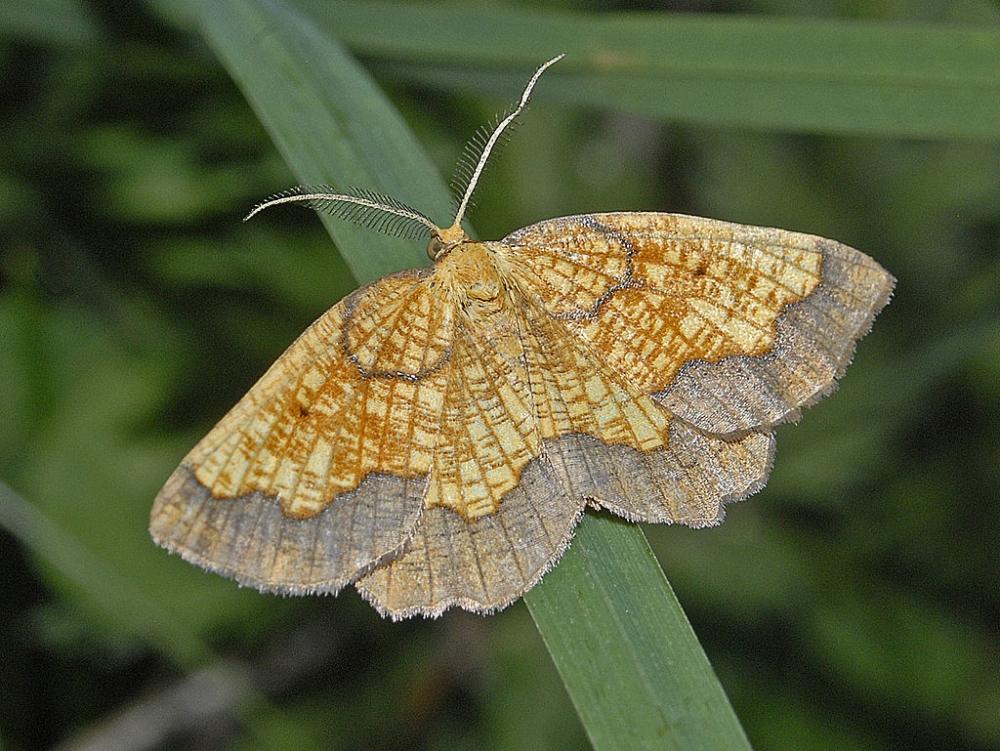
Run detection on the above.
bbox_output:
[181,0,452,283]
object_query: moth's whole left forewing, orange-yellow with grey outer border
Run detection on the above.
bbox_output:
[150,272,450,592]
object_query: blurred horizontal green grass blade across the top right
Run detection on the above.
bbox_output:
[296,0,1000,139]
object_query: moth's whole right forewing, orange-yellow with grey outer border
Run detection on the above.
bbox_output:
[498,213,894,435]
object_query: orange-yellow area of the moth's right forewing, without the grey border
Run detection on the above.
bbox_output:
[501,214,822,393]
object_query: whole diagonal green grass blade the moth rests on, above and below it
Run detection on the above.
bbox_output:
[174,0,747,749]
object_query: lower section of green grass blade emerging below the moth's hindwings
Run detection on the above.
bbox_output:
[524,515,750,751]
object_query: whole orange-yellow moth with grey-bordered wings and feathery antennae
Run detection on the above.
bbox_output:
[150,56,894,619]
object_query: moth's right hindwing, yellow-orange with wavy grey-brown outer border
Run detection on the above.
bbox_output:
[523,290,773,526]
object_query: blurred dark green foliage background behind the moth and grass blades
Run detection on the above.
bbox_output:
[0,0,1000,751]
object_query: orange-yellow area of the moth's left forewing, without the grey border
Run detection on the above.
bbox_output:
[184,274,450,518]
